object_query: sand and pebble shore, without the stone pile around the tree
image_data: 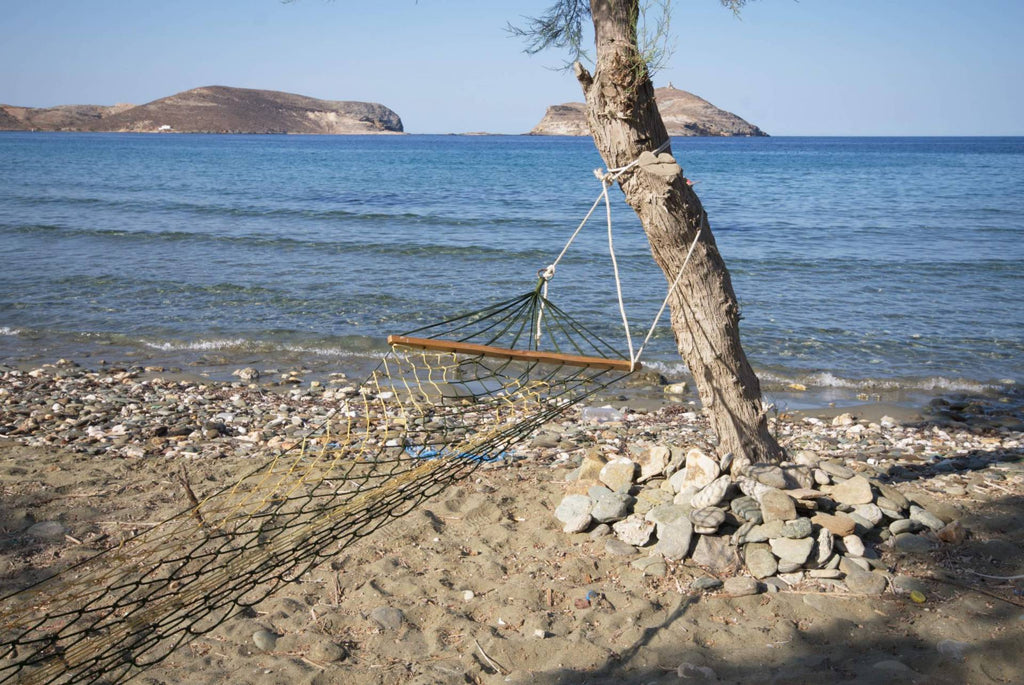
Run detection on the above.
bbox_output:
[0,361,1024,684]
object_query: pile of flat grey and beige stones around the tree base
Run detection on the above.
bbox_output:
[555,438,966,594]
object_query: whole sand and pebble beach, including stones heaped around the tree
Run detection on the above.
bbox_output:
[0,360,1024,683]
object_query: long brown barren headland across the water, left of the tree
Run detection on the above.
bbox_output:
[0,86,402,133]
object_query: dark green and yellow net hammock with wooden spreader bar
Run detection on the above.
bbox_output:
[0,279,634,683]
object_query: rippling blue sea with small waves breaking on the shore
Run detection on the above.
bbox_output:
[0,132,1024,406]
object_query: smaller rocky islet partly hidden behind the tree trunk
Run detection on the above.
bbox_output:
[530,85,768,136]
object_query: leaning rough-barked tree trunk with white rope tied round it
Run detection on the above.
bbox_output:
[575,0,782,470]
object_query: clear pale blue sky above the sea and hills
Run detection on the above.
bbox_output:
[0,0,1024,135]
